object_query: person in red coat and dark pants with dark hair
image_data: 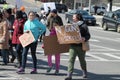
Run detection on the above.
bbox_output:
[12,11,25,68]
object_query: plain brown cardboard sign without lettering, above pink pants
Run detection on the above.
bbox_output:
[43,36,69,55]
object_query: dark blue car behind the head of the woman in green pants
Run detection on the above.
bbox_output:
[65,10,96,25]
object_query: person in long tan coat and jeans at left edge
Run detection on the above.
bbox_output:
[0,12,9,65]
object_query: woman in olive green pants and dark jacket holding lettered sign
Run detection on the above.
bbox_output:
[65,14,90,80]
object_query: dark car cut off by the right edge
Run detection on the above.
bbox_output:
[102,11,120,32]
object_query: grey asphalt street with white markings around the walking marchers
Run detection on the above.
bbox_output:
[0,0,120,80]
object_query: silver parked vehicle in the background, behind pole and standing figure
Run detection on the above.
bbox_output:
[84,5,107,15]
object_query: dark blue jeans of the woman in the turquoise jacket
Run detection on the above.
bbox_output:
[22,41,37,69]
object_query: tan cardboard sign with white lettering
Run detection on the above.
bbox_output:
[55,24,81,44]
